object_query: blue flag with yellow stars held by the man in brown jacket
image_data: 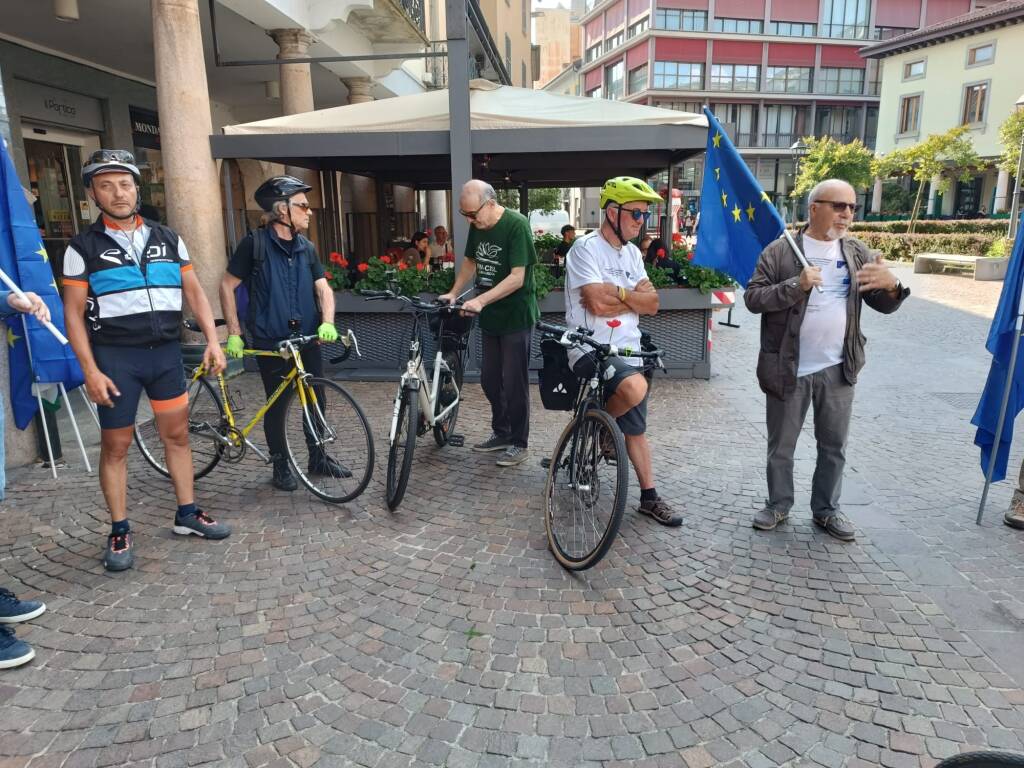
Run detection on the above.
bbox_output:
[693,106,783,286]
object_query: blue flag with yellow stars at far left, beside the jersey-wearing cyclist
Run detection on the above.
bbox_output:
[0,140,85,429]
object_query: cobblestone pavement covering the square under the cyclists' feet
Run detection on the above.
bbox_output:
[0,269,1024,768]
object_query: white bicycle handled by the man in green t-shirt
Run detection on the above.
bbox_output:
[360,291,473,510]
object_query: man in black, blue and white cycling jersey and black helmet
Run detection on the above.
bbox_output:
[63,150,231,570]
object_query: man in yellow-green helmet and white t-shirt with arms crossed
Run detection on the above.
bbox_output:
[565,176,683,526]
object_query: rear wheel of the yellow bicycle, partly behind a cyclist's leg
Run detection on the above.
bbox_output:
[135,378,227,480]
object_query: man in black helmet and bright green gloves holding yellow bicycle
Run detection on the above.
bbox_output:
[220,176,351,490]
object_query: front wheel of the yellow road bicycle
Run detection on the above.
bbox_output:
[285,377,374,504]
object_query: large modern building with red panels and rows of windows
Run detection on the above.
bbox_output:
[582,0,973,217]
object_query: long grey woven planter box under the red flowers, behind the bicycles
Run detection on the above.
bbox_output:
[324,288,712,381]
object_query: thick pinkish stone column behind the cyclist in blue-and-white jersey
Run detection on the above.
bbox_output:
[153,0,227,316]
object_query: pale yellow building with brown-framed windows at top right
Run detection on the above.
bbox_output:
[863,2,1024,216]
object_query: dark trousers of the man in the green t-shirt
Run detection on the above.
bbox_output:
[480,328,532,447]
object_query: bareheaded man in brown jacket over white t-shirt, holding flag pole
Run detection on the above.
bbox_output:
[743,179,910,542]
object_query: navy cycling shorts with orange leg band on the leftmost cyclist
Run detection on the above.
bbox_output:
[92,341,188,429]
